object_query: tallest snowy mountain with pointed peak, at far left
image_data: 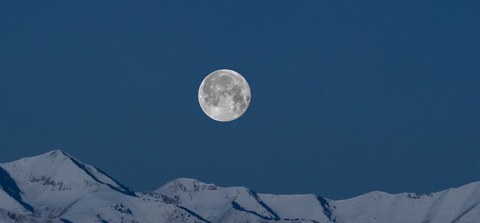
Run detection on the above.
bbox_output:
[0,150,218,222]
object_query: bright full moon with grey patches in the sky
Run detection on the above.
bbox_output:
[198,69,251,122]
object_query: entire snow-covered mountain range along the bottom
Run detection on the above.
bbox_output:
[0,150,480,223]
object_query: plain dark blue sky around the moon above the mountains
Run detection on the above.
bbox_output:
[0,0,480,198]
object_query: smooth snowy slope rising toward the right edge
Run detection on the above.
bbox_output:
[333,182,480,222]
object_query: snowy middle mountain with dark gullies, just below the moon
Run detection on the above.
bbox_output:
[154,178,330,222]
